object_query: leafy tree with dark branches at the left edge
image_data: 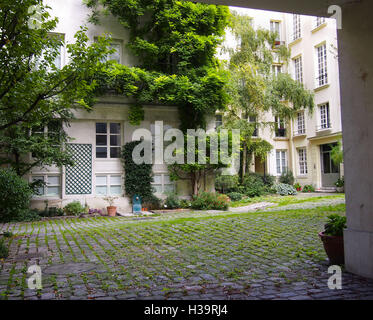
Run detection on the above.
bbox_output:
[0,0,110,175]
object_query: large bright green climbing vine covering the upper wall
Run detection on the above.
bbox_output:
[86,0,230,130]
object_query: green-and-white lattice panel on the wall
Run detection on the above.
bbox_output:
[65,144,92,195]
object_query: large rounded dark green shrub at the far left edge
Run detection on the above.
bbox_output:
[0,169,33,222]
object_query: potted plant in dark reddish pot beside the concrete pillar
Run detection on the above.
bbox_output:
[319,214,346,265]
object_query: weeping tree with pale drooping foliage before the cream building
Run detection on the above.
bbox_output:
[224,12,314,178]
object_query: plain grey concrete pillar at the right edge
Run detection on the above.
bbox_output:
[338,0,373,278]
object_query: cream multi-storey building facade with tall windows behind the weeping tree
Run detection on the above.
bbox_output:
[221,8,343,190]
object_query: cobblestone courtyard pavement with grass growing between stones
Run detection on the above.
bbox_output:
[0,198,373,300]
